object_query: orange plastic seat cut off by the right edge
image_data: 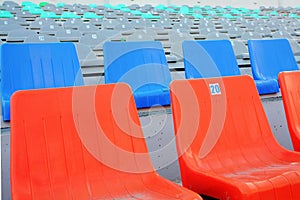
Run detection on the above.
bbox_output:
[279,71,300,151]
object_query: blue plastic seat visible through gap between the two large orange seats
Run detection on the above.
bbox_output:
[103,41,171,108]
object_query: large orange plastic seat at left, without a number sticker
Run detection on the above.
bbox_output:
[11,84,201,200]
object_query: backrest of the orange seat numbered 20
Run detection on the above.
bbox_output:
[170,76,283,178]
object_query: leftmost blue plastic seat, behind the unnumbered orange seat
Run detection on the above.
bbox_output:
[0,43,83,121]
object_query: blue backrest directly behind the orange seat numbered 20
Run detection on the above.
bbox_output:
[182,40,241,79]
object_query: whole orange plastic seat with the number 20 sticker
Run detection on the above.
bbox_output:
[171,76,300,200]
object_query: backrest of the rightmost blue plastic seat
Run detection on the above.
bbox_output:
[248,39,298,80]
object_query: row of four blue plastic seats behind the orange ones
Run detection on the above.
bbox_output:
[1,39,299,121]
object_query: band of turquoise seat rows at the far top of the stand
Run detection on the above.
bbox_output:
[0,1,299,19]
